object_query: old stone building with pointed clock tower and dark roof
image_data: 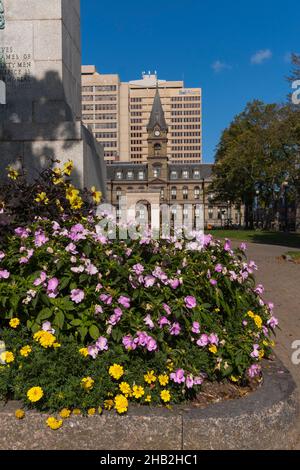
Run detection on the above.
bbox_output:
[107,91,243,227]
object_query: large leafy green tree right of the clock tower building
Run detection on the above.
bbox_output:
[212,100,299,228]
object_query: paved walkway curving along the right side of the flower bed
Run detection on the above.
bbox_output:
[248,243,300,450]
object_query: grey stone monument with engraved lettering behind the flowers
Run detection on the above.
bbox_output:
[0,0,106,193]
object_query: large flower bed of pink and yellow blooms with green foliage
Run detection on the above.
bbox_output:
[0,164,278,429]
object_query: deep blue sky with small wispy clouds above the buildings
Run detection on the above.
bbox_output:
[81,0,300,163]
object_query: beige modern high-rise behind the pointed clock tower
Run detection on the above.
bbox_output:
[82,65,202,164]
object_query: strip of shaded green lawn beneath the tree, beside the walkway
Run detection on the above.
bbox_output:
[207,229,300,249]
